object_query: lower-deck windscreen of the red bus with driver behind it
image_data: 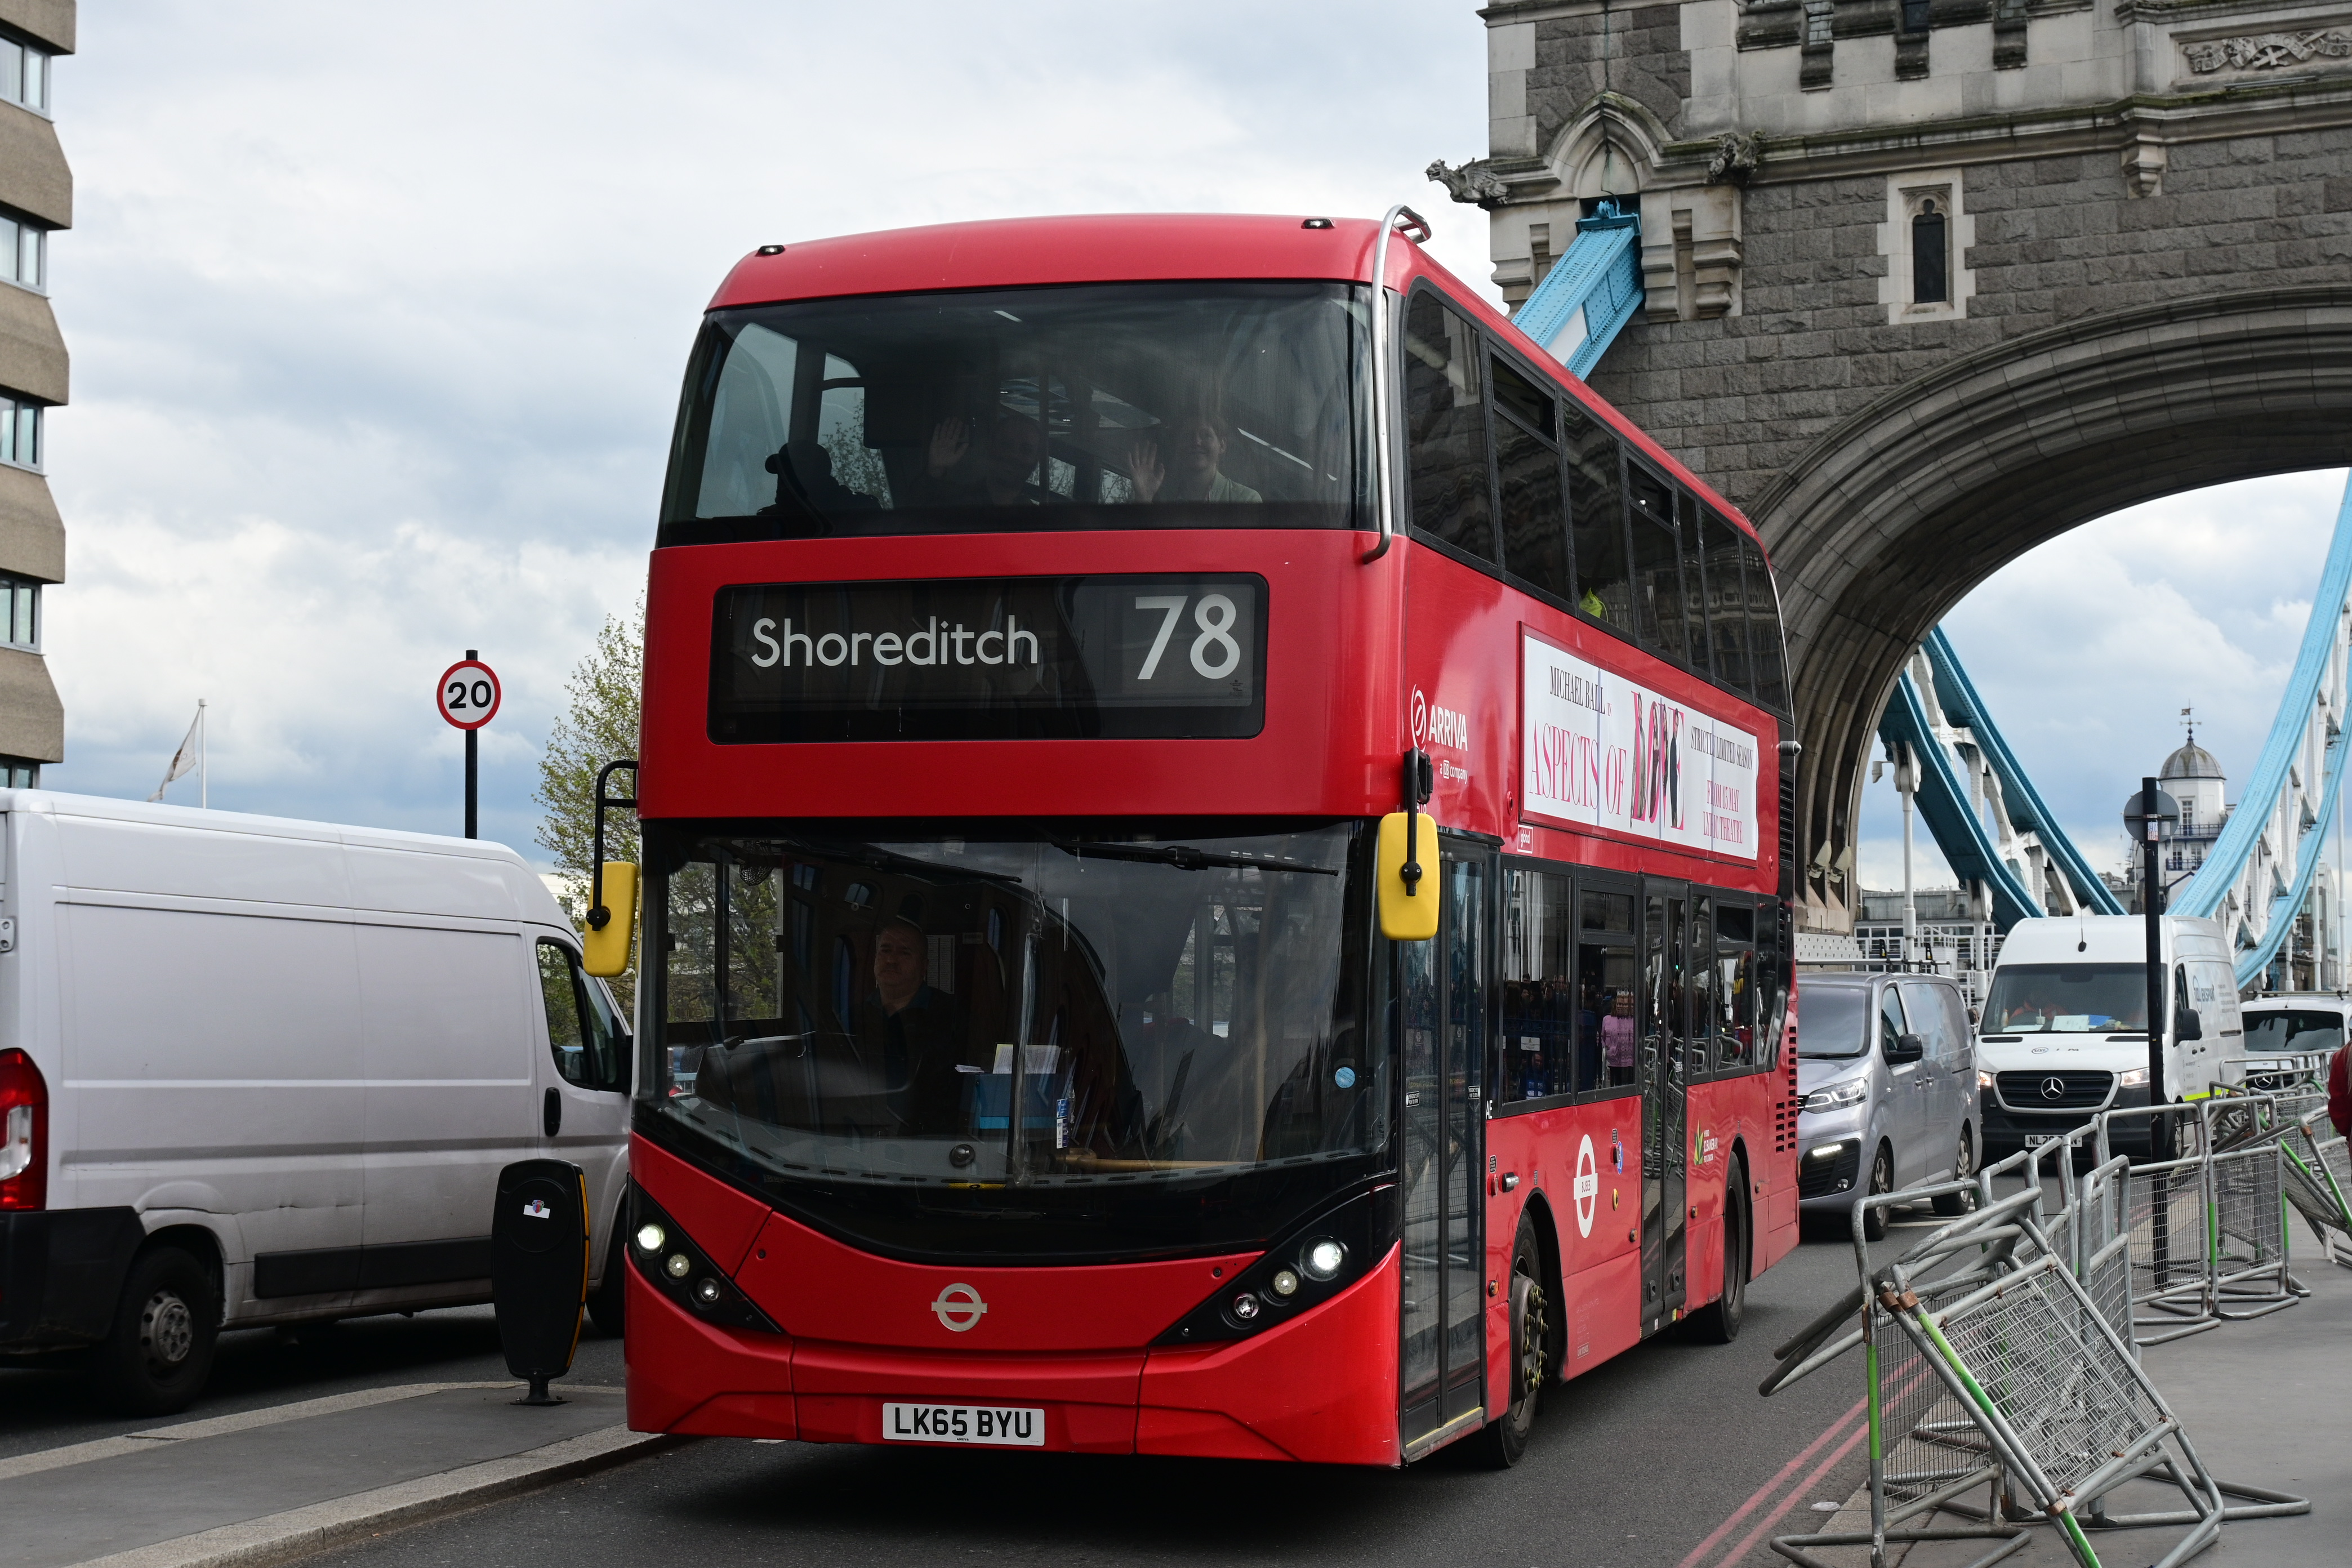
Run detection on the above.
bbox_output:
[640,823,1388,1258]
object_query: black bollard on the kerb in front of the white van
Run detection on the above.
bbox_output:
[489,1159,588,1406]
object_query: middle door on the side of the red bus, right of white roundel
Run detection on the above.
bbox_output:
[1640,879,1691,1333]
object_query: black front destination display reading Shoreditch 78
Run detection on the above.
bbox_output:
[710,573,1266,745]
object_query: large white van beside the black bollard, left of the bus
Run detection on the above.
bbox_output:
[0,790,630,1413]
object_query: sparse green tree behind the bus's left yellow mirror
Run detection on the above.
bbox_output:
[532,599,644,1013]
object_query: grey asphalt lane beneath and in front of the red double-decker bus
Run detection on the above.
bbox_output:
[289,1232,1905,1568]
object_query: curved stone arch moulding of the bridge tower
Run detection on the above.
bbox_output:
[1748,284,2352,929]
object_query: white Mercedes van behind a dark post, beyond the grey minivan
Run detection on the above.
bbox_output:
[1976,915,2244,1159]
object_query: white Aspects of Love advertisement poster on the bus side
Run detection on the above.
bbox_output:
[1520,627,1757,861]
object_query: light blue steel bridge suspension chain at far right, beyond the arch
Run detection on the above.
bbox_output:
[2171,472,2352,985]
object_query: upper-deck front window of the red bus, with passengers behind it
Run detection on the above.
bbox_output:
[658,282,1371,545]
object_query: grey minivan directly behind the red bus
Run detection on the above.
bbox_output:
[1797,973,1983,1241]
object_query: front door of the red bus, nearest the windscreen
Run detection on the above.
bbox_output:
[1397,837,1496,1458]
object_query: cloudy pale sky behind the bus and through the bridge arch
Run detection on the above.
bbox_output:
[44,0,2340,884]
